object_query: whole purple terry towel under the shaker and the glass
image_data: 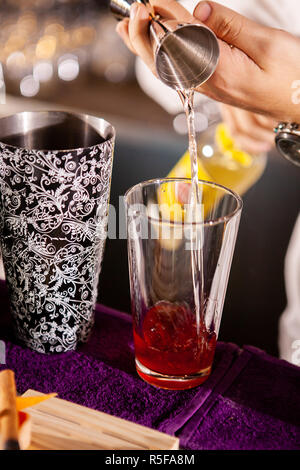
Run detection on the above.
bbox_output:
[0,285,300,449]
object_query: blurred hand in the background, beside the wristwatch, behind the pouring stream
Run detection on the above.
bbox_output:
[221,104,277,154]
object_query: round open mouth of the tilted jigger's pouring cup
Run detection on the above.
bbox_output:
[155,23,220,90]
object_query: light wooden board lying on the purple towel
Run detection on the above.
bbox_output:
[23,390,179,450]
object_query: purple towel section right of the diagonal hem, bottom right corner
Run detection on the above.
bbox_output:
[181,346,300,450]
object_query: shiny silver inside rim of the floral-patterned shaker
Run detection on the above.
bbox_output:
[0,109,116,153]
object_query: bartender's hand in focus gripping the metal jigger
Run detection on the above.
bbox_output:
[118,0,300,121]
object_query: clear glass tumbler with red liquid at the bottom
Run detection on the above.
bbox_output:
[125,178,242,390]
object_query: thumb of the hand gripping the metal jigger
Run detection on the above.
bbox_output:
[194,2,268,63]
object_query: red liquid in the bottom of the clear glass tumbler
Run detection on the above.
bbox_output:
[134,301,217,389]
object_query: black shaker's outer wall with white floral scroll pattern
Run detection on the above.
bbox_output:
[0,139,113,353]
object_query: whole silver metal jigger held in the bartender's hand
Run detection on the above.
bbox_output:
[110,0,220,90]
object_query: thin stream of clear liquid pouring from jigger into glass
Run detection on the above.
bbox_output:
[177,89,204,329]
